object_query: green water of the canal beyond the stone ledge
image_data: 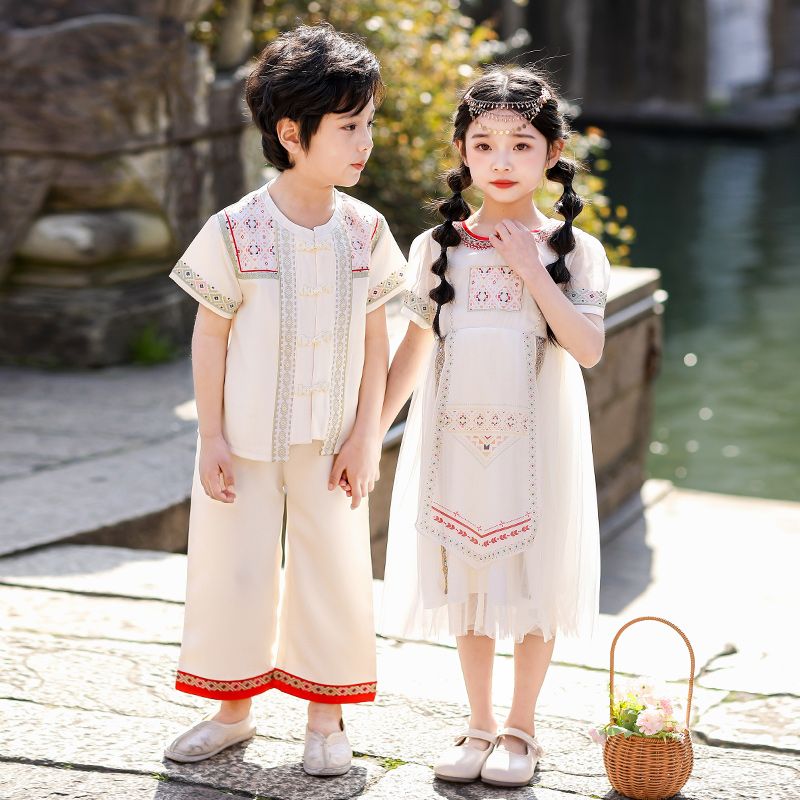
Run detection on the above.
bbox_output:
[607,130,800,500]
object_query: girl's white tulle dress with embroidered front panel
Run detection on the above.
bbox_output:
[381,220,610,641]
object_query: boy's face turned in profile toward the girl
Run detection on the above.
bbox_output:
[291,100,375,186]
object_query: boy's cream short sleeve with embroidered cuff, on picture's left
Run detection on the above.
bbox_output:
[169,216,242,319]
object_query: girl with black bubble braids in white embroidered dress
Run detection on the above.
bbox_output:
[381,68,610,786]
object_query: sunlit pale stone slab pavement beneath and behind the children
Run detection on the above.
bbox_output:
[0,354,800,800]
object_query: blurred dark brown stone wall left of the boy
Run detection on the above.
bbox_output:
[0,0,255,366]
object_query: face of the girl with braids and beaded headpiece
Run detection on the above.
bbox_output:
[456,110,564,203]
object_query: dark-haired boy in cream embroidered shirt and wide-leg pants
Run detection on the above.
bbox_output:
[165,25,406,775]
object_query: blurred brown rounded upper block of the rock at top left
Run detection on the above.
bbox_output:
[0,14,209,158]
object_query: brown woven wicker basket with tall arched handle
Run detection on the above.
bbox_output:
[603,617,694,800]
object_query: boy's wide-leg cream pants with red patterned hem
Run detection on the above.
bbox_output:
[175,442,376,703]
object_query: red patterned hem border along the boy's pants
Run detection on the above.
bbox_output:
[175,669,377,703]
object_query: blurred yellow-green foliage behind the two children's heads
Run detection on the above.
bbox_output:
[195,0,634,264]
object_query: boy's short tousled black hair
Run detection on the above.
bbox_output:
[245,22,384,172]
